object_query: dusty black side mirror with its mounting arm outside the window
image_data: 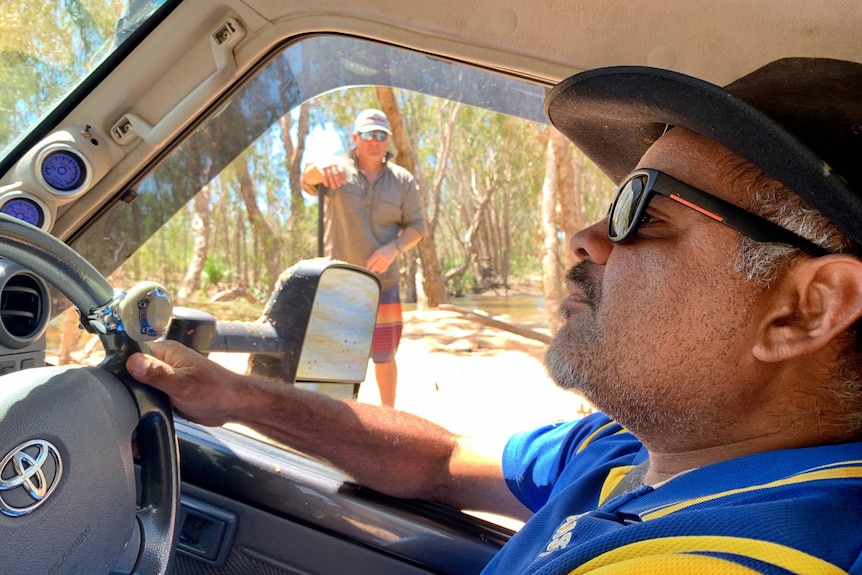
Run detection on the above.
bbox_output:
[167,258,380,384]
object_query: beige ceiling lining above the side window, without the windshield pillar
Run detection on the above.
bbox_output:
[248,0,862,84]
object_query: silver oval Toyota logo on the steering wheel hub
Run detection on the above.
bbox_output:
[0,439,63,517]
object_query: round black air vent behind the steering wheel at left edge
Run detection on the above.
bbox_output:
[0,268,50,349]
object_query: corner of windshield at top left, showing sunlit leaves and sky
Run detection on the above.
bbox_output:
[0,0,167,157]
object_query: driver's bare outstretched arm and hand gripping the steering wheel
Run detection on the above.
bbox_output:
[127,341,530,519]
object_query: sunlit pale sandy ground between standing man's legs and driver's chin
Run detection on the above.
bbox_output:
[352,310,591,433]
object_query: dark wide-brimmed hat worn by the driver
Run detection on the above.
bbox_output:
[544,58,862,245]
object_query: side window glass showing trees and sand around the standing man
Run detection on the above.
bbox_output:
[49,36,612,450]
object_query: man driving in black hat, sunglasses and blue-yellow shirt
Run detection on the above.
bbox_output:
[127,58,862,574]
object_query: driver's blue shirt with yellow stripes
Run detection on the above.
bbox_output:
[484,414,862,575]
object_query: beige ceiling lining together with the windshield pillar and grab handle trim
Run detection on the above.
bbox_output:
[6,0,862,239]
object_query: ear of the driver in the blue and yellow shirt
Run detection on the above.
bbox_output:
[752,254,862,362]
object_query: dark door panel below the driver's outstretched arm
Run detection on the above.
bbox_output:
[175,420,511,575]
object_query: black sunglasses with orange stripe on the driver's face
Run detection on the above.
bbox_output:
[608,169,830,257]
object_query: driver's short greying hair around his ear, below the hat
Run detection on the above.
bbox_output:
[726,158,862,436]
